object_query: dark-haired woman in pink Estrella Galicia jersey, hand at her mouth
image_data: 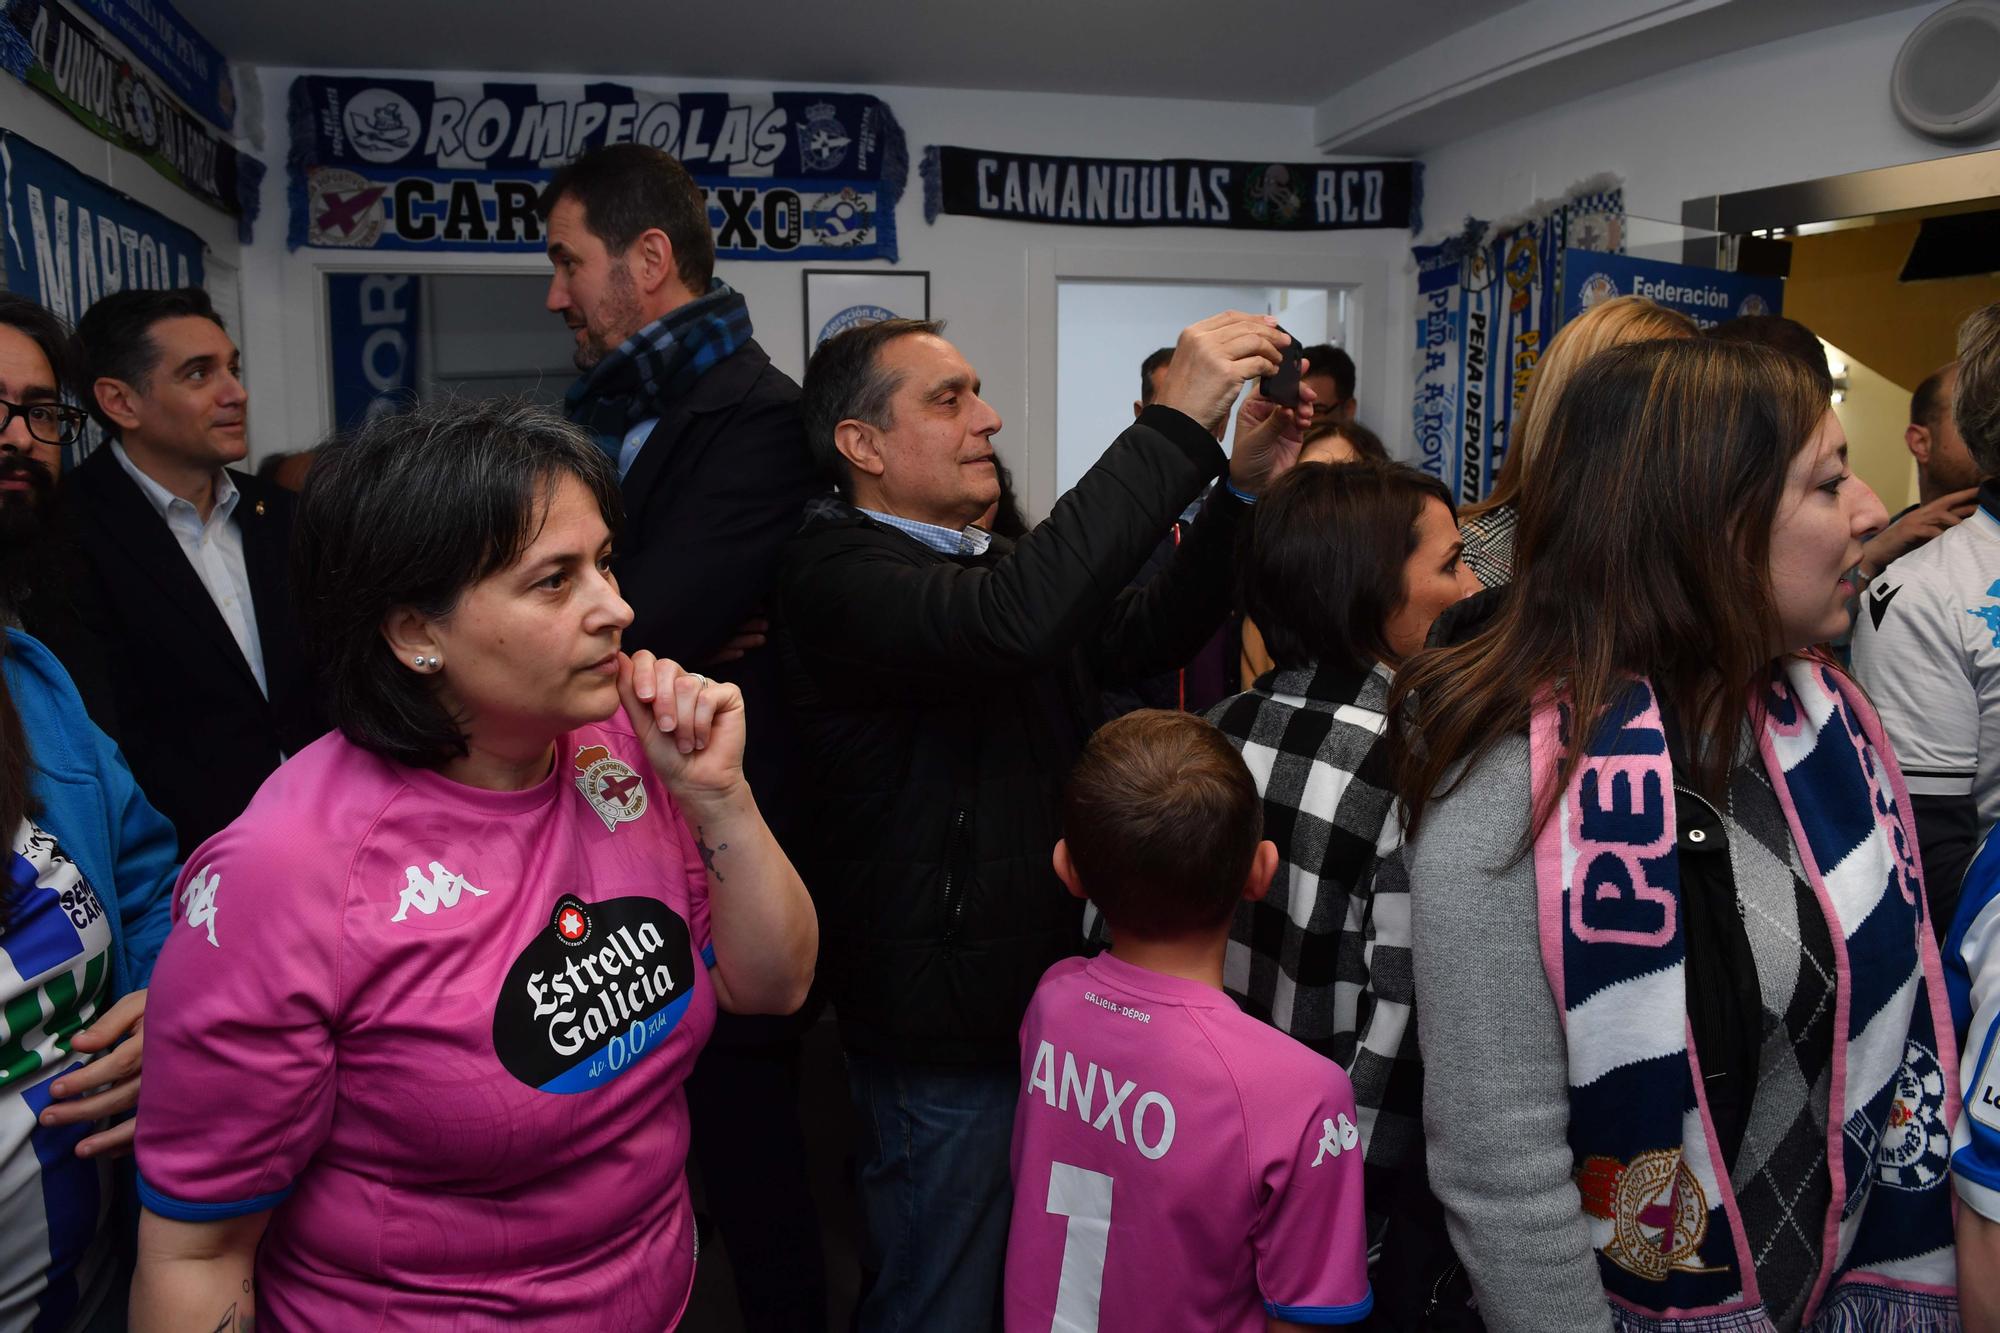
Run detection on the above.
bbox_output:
[132,404,818,1333]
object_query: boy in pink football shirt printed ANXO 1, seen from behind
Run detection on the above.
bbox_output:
[1006,711,1372,1333]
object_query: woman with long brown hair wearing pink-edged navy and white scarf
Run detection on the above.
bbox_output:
[1390,340,1958,1333]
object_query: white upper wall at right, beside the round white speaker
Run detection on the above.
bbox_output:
[1424,4,1982,234]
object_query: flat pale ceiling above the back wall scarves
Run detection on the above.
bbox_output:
[176,0,1520,106]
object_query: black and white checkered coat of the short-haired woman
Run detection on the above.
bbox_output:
[1208,667,1424,1211]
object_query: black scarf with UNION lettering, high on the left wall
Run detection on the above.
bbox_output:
[0,0,264,233]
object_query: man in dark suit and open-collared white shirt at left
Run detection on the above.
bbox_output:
[64,288,324,857]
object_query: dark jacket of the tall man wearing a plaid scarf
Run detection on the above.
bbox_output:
[614,340,828,835]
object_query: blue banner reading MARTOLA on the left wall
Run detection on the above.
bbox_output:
[0,130,204,324]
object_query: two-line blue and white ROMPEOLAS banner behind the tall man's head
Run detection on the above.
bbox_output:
[288,74,910,260]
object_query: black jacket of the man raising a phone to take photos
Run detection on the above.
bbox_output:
[776,406,1244,1065]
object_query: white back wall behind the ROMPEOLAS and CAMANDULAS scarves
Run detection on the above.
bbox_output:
[244,68,1410,514]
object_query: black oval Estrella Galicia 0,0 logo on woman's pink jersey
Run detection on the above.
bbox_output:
[494,893,696,1093]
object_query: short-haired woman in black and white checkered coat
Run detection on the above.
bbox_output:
[1208,462,1478,1309]
